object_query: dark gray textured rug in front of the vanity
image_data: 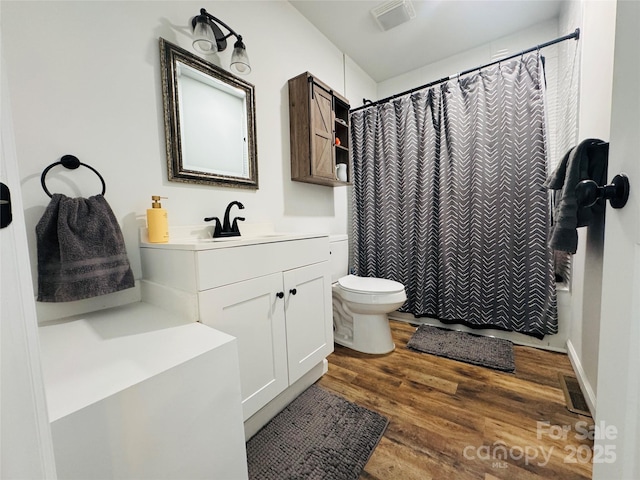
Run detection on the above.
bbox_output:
[247,385,389,480]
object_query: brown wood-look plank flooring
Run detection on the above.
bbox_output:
[319,321,593,480]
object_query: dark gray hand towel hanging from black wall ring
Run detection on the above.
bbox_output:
[36,193,135,302]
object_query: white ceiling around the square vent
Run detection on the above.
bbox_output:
[289,0,563,82]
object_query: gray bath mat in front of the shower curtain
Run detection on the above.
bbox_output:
[407,325,516,372]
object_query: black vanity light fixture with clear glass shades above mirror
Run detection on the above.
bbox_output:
[191,8,251,75]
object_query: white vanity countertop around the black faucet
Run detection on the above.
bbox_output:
[140,225,329,250]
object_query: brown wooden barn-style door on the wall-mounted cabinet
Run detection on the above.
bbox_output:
[309,82,336,180]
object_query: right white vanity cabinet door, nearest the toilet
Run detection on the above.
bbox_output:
[284,262,333,384]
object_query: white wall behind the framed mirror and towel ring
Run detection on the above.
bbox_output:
[0,0,376,320]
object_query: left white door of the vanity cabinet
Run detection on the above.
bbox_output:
[198,273,288,420]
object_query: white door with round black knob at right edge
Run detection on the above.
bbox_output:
[593,0,640,480]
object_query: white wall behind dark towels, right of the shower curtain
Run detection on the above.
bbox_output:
[561,0,616,412]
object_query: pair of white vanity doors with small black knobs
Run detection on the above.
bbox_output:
[198,262,333,420]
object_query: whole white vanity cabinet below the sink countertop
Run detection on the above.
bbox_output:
[141,235,333,430]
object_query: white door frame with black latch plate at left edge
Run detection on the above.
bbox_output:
[0,58,57,479]
